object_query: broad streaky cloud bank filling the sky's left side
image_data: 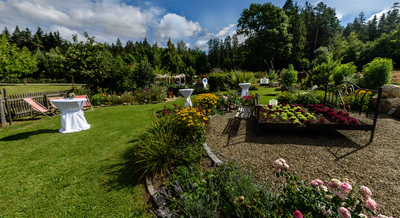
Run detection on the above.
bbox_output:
[0,0,163,40]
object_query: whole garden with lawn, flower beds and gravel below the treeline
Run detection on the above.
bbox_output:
[0,57,400,217]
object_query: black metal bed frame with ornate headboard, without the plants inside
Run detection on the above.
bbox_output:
[255,81,382,142]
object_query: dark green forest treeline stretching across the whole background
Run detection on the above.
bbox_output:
[0,0,400,90]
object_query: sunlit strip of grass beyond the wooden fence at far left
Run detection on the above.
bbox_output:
[0,85,79,95]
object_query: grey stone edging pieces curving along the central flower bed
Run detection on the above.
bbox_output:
[146,114,222,217]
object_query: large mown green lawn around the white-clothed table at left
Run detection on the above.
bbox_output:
[0,98,184,217]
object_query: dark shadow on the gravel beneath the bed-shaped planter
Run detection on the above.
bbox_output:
[238,119,370,160]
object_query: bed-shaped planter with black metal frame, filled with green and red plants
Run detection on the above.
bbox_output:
[251,81,382,142]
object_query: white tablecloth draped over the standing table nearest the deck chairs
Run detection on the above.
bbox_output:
[51,98,90,133]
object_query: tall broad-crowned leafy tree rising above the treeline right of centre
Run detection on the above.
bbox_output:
[237,3,292,68]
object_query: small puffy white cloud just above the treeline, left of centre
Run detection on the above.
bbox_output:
[155,13,201,41]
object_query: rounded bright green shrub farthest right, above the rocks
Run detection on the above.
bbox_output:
[363,58,393,89]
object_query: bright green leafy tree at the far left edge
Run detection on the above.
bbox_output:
[0,34,37,79]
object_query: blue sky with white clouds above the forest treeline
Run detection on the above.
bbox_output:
[0,0,396,50]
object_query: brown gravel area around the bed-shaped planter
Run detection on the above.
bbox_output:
[206,113,400,217]
